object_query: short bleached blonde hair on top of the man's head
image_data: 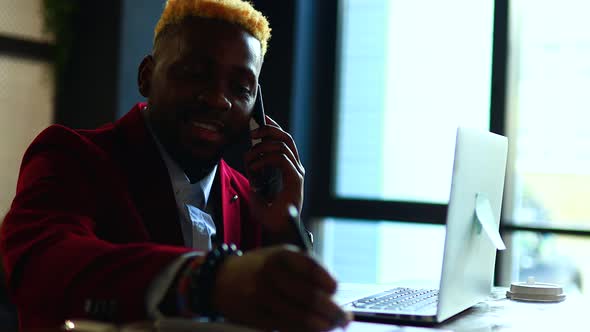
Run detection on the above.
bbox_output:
[154,0,271,57]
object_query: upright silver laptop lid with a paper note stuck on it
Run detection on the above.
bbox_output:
[437,128,508,322]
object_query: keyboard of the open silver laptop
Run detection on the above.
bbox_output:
[352,287,438,311]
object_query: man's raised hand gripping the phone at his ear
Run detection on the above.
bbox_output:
[245,116,305,239]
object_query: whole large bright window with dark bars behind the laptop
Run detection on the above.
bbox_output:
[311,0,590,292]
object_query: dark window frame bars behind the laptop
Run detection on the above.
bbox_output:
[293,0,590,284]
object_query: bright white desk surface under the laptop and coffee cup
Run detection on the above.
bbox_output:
[61,283,590,332]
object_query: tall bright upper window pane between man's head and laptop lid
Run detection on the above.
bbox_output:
[335,0,494,204]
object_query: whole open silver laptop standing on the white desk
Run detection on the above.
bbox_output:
[343,127,508,325]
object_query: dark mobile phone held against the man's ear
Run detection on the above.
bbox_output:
[250,84,283,203]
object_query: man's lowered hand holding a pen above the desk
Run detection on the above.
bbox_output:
[212,246,349,331]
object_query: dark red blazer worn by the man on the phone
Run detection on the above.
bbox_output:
[0,104,261,328]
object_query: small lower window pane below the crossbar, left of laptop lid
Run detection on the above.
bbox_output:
[317,218,445,283]
